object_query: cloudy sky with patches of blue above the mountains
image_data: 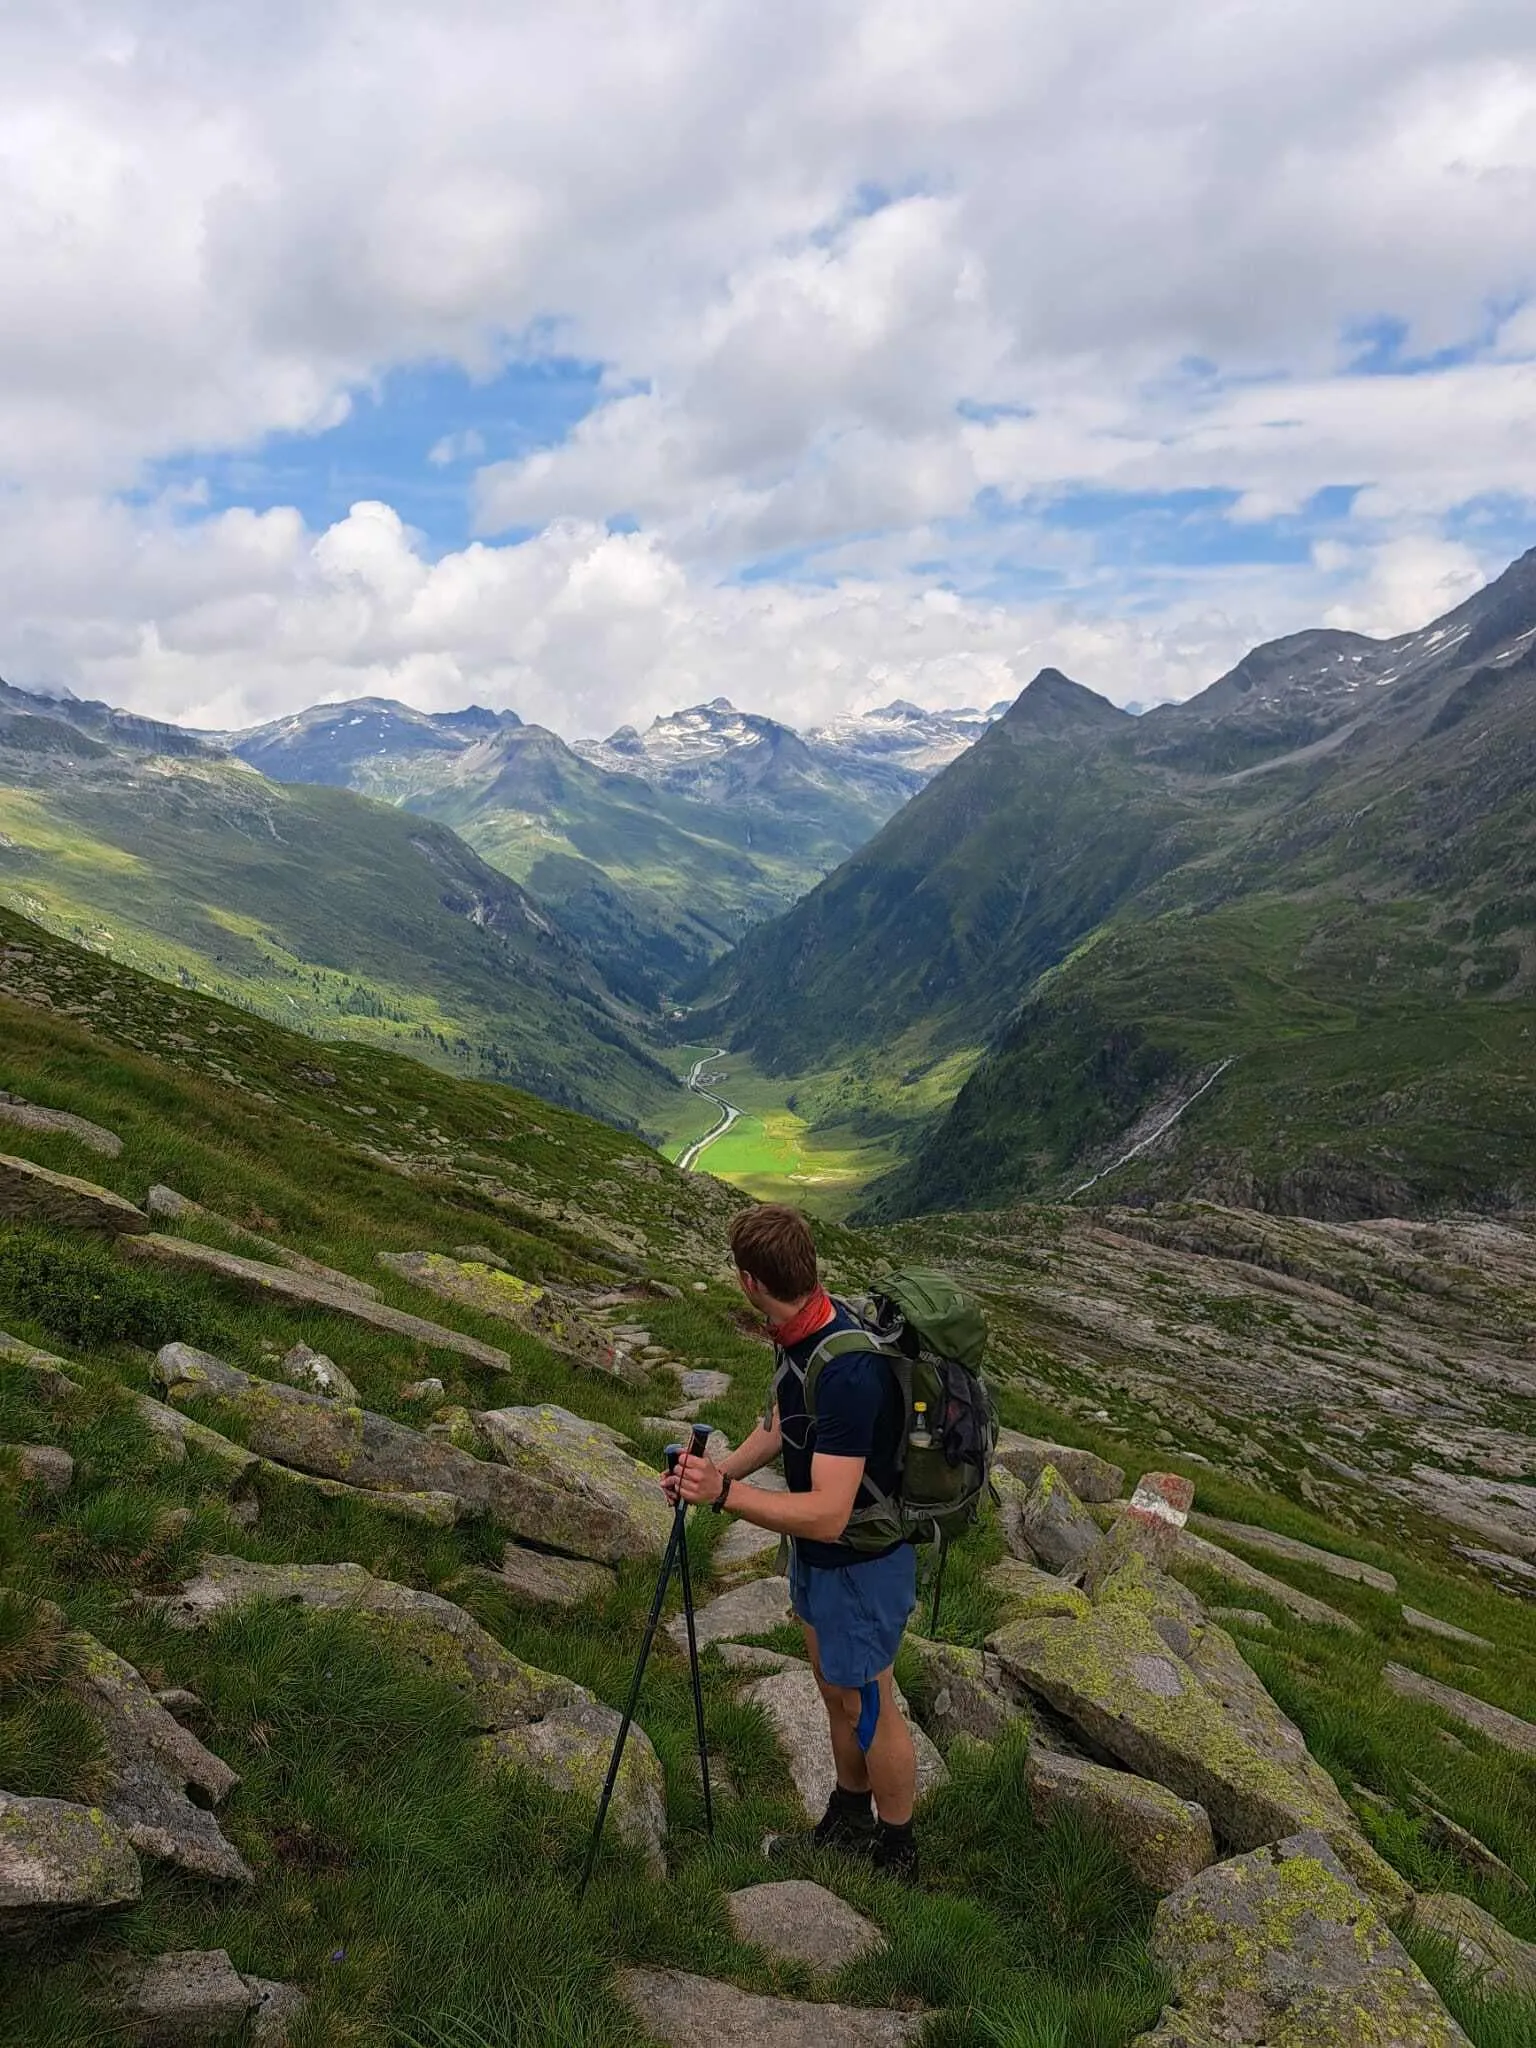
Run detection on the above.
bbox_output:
[0,0,1536,737]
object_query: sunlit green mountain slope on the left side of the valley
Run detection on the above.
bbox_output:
[0,690,676,1122]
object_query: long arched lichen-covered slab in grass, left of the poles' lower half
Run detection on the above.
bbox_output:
[154,1556,588,1729]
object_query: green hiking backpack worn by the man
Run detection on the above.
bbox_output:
[770,1266,997,1616]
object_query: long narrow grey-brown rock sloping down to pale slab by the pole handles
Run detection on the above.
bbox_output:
[156,1343,638,1563]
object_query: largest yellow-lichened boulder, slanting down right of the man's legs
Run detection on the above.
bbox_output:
[989,1599,1407,1911]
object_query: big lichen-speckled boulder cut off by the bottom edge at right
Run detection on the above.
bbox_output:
[1137,1833,1468,2048]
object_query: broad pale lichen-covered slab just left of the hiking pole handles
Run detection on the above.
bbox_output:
[475,1405,672,1563]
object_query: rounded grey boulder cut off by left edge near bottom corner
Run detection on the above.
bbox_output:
[0,1792,143,1944]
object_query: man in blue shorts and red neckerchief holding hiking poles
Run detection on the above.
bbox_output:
[666,1204,918,1882]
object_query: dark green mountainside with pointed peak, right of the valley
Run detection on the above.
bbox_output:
[716,551,1536,1217]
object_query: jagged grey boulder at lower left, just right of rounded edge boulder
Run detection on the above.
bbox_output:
[66,1632,252,1884]
